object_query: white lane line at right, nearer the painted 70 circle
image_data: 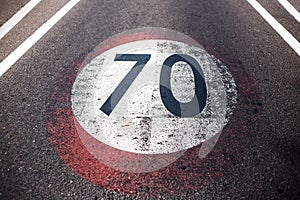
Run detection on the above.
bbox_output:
[247,0,300,56]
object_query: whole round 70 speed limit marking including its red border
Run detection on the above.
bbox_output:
[46,28,261,196]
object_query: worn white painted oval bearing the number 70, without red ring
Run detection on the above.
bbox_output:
[71,40,237,154]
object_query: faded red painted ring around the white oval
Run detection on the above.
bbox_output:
[46,28,260,196]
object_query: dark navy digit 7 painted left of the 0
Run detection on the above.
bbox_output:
[100,54,151,116]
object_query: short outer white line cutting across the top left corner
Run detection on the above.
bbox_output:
[0,0,41,40]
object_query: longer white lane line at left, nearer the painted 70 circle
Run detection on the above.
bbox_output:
[0,0,80,77]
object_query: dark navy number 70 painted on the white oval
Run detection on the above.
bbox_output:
[100,54,207,117]
